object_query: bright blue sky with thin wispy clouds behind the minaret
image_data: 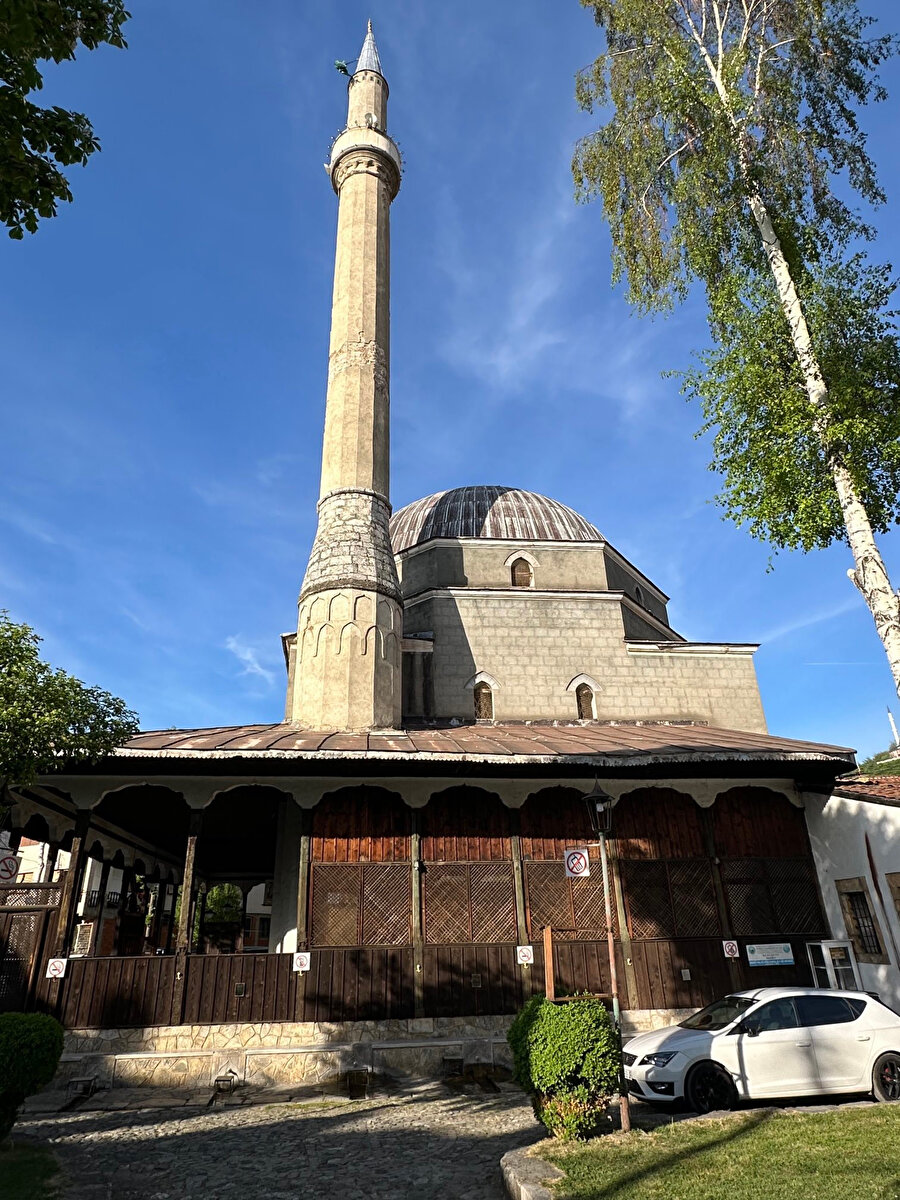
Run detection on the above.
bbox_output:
[0,0,900,754]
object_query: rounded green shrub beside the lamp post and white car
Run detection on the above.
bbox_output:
[508,996,619,1140]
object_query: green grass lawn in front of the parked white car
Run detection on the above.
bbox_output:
[541,1104,900,1200]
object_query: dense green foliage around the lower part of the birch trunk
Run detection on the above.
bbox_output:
[683,254,900,551]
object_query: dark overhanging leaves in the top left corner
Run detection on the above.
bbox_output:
[0,0,130,239]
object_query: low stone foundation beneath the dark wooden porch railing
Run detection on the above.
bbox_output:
[56,1009,691,1088]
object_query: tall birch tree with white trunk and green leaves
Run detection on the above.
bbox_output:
[572,0,900,692]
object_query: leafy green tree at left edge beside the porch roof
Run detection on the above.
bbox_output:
[0,612,138,800]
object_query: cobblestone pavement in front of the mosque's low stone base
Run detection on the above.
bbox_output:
[16,1085,541,1200]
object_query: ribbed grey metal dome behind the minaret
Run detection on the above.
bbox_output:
[391,486,604,554]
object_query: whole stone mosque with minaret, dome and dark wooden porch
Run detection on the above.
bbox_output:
[1,24,853,1085]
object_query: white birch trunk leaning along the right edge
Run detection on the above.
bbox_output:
[748,192,900,695]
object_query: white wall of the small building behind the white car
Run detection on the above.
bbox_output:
[805,796,900,1012]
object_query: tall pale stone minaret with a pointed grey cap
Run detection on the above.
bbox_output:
[287,22,402,730]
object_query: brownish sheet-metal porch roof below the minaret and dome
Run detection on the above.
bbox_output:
[115,721,853,773]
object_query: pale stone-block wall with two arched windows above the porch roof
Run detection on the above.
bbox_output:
[404,589,766,732]
